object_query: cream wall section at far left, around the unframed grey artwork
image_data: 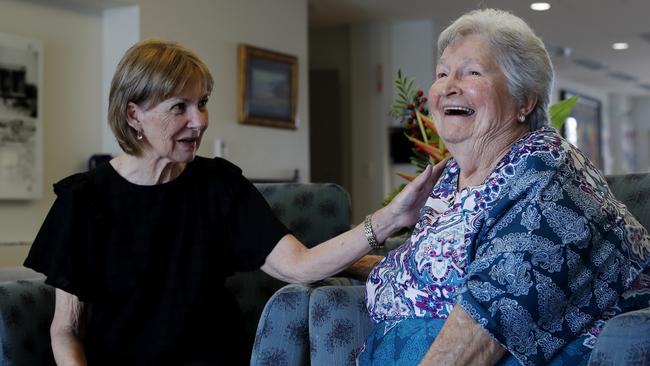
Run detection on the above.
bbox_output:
[0,0,102,266]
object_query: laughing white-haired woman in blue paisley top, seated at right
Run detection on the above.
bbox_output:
[358,9,650,365]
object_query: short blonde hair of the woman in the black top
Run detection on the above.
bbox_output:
[108,39,214,156]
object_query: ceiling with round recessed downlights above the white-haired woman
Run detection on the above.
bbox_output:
[309,0,650,96]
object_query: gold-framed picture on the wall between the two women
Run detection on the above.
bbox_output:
[239,44,298,129]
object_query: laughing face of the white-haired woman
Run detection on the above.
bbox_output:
[429,34,522,153]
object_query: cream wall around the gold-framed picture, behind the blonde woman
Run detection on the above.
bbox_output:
[130,0,309,180]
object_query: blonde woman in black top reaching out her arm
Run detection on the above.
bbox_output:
[25,40,439,366]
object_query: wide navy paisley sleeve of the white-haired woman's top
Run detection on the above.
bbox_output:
[457,136,647,365]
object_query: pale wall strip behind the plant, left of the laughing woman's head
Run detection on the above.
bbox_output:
[350,20,436,222]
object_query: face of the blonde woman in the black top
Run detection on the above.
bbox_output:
[129,77,208,163]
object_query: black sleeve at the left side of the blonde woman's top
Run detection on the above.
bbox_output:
[24,173,93,301]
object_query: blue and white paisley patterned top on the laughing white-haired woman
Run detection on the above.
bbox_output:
[366,127,650,365]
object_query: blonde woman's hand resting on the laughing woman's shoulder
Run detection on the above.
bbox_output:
[387,158,449,227]
